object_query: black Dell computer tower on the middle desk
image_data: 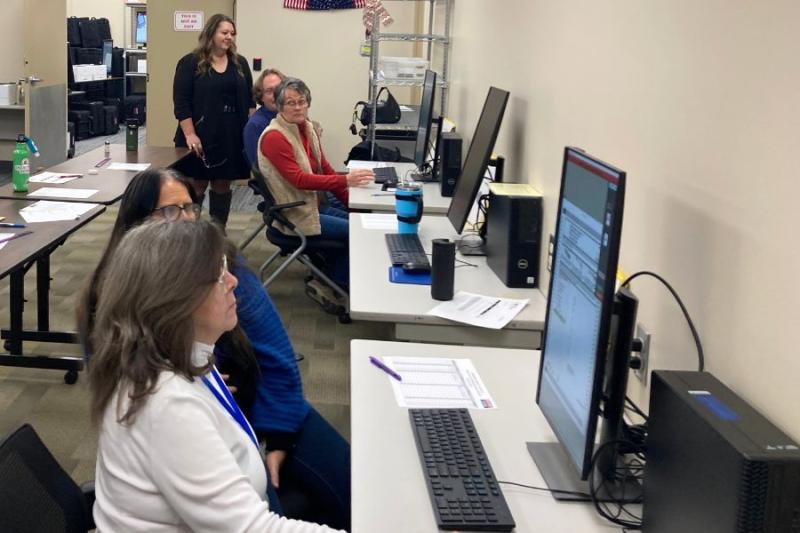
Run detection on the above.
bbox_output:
[486,183,542,288]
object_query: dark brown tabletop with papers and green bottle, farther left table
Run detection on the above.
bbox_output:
[0,144,189,205]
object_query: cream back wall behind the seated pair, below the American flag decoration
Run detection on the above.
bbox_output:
[236,0,416,169]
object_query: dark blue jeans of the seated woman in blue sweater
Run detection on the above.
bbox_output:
[278,407,350,530]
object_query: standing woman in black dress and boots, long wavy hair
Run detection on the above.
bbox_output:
[172,14,255,226]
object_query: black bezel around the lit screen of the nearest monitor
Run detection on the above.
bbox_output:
[536,146,626,480]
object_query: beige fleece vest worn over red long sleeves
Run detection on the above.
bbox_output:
[257,113,322,236]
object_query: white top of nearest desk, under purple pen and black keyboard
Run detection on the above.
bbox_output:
[350,340,619,533]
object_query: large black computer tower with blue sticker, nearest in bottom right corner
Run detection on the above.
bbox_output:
[642,371,800,533]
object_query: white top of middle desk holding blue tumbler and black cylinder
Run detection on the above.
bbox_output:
[350,213,547,331]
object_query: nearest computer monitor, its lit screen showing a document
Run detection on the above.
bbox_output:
[529,147,636,499]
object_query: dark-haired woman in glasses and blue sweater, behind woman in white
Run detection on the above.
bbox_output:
[78,169,350,529]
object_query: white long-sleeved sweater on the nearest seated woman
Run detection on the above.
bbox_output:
[94,343,344,533]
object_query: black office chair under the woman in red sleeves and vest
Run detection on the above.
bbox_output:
[248,165,350,324]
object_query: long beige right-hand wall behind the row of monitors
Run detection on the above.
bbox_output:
[450,0,800,440]
